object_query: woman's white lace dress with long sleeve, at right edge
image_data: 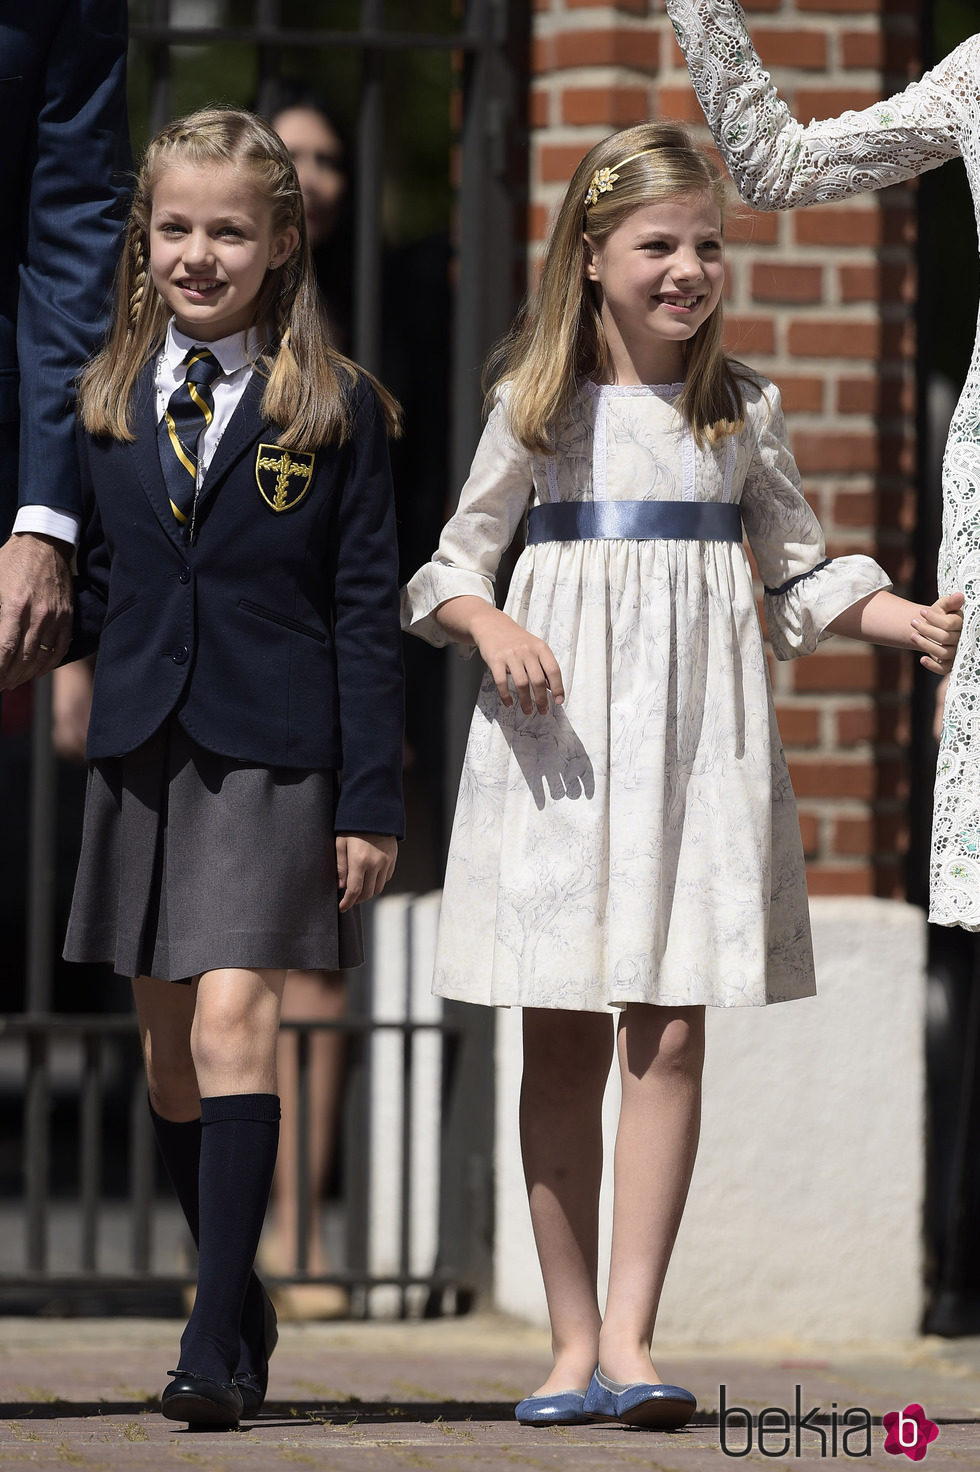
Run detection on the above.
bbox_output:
[667,0,980,930]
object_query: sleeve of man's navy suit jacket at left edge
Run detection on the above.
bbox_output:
[18,0,129,515]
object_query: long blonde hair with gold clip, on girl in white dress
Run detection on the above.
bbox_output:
[487,122,745,455]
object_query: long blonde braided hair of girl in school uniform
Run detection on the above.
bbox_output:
[78,107,400,449]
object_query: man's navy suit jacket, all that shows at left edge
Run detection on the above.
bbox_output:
[0,0,129,540]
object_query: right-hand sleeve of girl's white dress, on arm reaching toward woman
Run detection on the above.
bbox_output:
[742,380,892,659]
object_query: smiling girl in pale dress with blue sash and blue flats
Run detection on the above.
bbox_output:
[403,122,962,1428]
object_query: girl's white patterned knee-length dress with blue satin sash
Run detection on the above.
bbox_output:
[403,380,889,1011]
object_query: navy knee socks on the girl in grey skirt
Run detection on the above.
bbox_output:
[150,1094,280,1381]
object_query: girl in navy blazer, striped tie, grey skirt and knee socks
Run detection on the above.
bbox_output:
[65,109,403,1426]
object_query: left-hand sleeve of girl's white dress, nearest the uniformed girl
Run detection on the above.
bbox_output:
[402,402,533,648]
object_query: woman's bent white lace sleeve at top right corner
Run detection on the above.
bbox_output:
[667,0,980,209]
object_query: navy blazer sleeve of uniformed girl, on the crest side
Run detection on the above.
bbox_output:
[334,384,405,838]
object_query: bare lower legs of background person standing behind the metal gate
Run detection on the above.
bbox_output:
[271,972,347,1273]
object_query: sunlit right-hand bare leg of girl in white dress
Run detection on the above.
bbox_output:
[599,1002,705,1384]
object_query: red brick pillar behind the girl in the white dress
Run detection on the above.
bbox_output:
[528,0,920,895]
